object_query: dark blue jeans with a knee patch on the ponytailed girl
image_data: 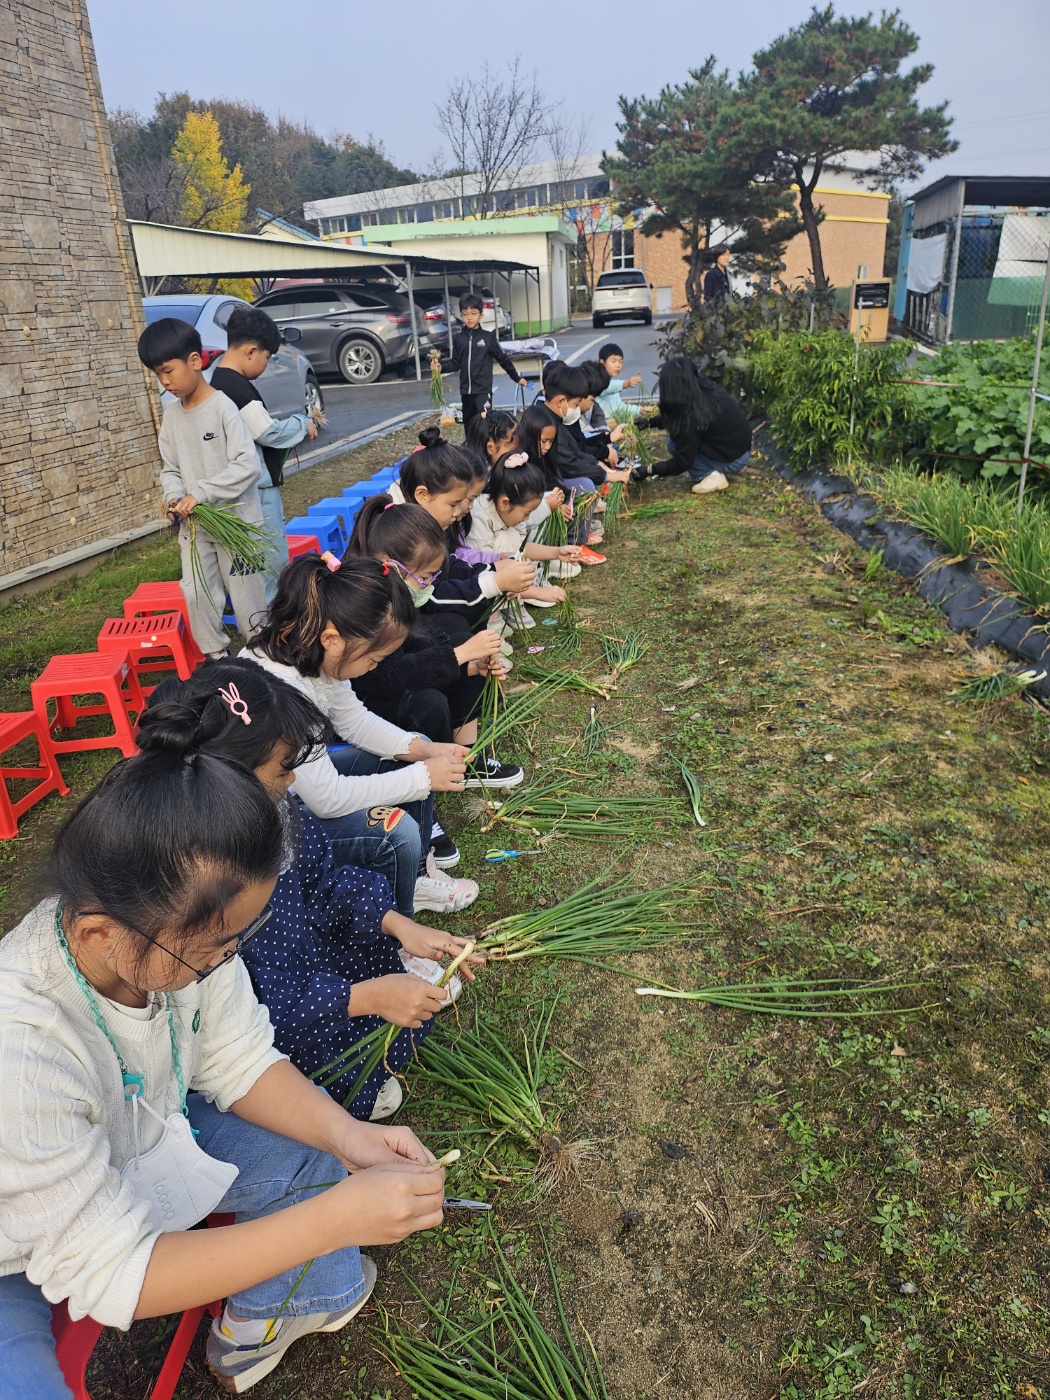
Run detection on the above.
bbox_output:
[314,743,434,918]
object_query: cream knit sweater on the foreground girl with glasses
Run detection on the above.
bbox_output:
[0,899,283,1329]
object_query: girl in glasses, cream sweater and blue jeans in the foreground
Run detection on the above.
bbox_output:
[0,739,444,1400]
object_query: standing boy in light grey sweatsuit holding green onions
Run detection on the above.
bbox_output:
[139,316,266,661]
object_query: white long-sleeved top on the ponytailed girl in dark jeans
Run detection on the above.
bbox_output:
[241,647,430,820]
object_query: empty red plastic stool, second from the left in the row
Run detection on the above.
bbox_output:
[31,647,144,759]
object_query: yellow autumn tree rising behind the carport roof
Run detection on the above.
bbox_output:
[171,112,252,298]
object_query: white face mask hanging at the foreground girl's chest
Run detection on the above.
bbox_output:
[120,1095,238,1233]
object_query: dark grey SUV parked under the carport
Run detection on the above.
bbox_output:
[256,283,427,384]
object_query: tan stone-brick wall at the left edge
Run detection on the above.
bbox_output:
[0,0,160,582]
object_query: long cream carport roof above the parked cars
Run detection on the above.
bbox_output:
[127,220,536,280]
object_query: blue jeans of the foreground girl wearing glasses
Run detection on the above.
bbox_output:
[0,1093,364,1400]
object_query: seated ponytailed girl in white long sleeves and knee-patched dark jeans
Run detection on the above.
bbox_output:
[241,554,477,918]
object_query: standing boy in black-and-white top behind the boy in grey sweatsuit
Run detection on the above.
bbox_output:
[211,307,318,605]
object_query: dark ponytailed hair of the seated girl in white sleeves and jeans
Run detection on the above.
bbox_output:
[249,554,414,676]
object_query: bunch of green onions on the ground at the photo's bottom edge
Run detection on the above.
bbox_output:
[379,1217,609,1400]
